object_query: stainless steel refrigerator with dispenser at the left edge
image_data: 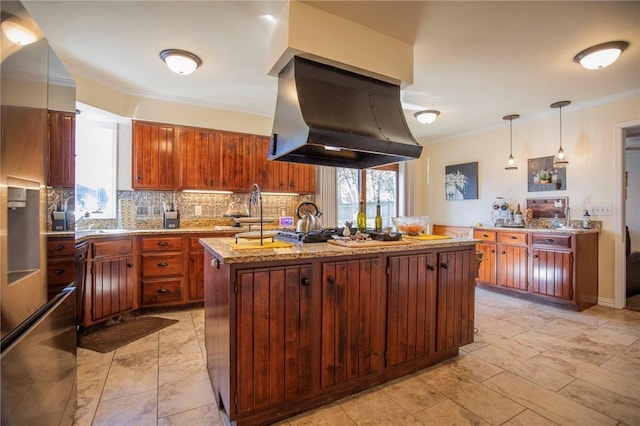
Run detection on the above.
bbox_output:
[0,0,77,426]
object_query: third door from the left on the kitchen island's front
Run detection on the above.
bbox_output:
[386,253,438,366]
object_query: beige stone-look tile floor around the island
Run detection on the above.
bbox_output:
[76,289,640,426]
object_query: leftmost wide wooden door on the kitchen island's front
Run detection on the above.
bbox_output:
[236,265,318,416]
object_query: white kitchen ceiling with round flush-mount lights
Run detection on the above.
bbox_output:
[23,0,640,143]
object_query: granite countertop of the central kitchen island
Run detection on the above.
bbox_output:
[200,238,481,263]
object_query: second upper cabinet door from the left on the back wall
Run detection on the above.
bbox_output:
[178,127,224,189]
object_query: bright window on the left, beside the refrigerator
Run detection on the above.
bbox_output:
[75,114,117,220]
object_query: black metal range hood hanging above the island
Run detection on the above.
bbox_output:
[267,56,422,169]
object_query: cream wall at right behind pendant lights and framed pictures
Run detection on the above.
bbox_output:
[413,92,640,301]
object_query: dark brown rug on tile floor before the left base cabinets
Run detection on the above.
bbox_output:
[78,317,178,353]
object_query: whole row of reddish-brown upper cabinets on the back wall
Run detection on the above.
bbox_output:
[132,120,316,194]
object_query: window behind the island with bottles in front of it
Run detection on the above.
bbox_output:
[336,164,398,228]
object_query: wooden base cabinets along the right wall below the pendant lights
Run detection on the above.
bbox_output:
[474,229,598,310]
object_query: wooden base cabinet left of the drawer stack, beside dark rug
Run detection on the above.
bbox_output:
[84,237,138,325]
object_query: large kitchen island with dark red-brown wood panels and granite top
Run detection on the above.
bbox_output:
[200,238,477,425]
